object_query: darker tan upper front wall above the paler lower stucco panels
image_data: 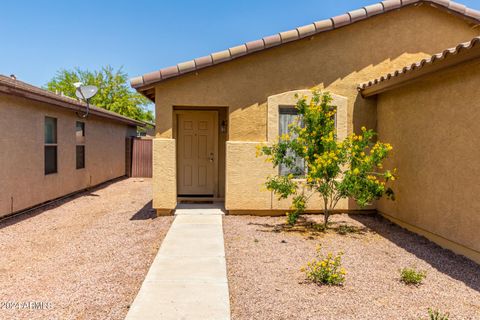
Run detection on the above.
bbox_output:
[154,5,479,210]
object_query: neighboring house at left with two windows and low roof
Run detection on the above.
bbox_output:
[0,76,143,217]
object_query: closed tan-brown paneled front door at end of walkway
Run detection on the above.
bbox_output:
[177,111,217,197]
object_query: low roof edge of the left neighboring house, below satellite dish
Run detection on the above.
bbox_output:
[0,75,145,126]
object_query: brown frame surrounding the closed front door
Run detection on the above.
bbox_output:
[172,109,219,198]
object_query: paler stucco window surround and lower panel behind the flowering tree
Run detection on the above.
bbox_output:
[225,90,349,212]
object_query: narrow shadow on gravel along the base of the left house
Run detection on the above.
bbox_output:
[0,177,128,230]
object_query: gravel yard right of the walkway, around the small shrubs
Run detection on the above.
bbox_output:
[224,215,480,320]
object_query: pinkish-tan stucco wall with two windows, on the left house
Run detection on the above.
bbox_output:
[0,94,135,216]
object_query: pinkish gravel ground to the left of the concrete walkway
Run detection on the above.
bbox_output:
[0,178,173,319]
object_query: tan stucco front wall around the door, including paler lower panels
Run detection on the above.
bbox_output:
[143,5,479,214]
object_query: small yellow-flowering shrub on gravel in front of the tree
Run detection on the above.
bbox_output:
[302,246,346,286]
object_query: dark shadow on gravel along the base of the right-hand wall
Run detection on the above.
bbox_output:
[349,214,480,292]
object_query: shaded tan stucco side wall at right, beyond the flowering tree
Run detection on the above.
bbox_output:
[377,60,480,263]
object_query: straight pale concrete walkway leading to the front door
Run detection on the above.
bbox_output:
[126,204,230,320]
